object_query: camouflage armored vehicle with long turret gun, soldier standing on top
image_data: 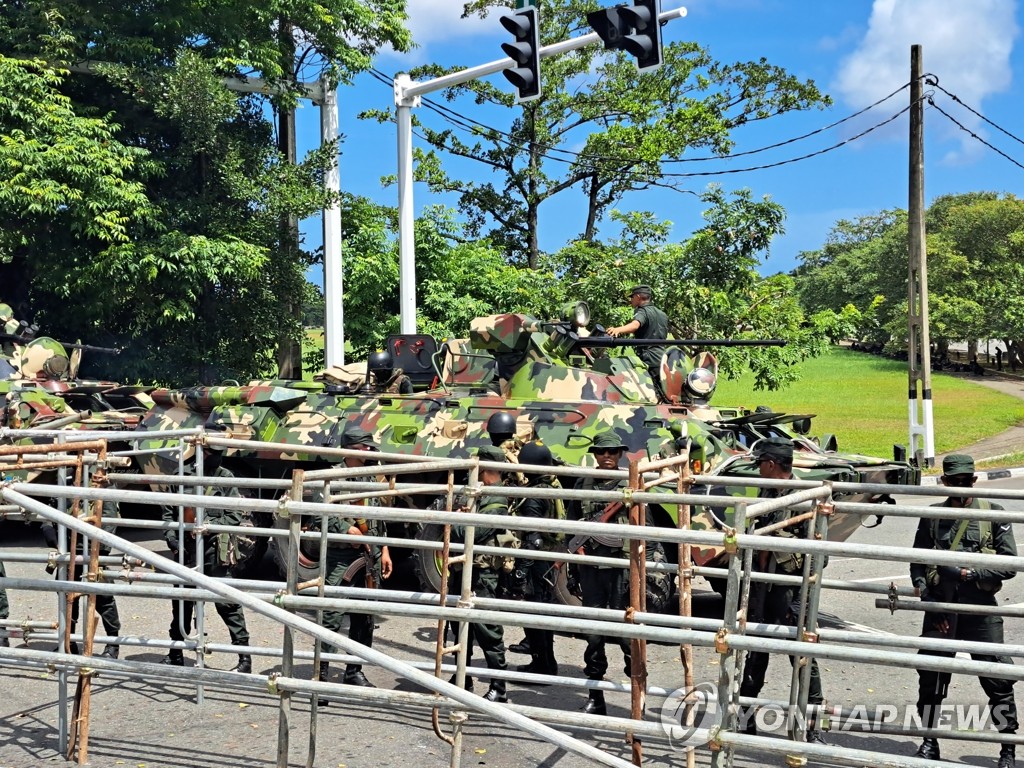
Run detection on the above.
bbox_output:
[130,304,913,593]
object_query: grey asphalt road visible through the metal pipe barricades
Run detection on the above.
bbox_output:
[0,479,1024,768]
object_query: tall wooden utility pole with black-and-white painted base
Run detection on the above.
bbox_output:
[906,45,935,468]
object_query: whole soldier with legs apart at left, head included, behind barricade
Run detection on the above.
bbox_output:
[161,444,252,675]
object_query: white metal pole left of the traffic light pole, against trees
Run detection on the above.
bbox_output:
[321,78,345,368]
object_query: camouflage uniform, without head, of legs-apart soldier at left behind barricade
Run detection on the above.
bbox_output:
[163,465,251,672]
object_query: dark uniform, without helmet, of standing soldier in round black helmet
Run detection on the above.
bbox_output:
[513,475,562,675]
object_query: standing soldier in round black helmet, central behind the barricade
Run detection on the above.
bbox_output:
[511,440,564,675]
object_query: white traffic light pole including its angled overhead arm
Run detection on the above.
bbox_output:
[394,3,686,334]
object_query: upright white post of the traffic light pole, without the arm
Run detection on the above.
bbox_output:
[394,73,420,334]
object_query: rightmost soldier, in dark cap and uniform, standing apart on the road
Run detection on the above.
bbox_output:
[910,454,1017,768]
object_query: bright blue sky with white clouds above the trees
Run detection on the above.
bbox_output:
[299,0,1024,282]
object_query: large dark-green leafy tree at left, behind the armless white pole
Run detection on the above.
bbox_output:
[0,0,409,383]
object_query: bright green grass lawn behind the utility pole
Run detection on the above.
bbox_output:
[713,347,1024,457]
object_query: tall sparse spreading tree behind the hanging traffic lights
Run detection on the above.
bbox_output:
[373,0,829,267]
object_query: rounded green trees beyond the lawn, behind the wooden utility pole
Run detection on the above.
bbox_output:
[795,193,1024,364]
